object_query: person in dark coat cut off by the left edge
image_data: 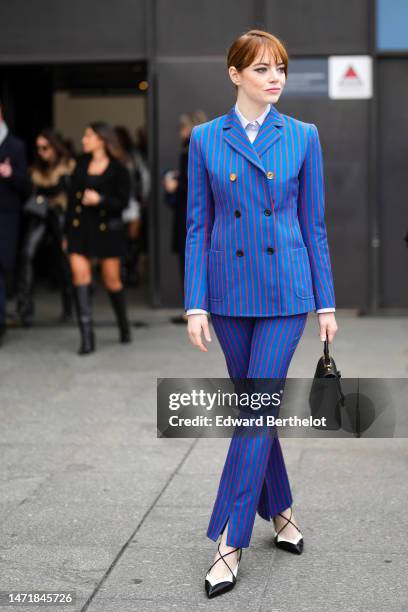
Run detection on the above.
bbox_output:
[0,100,30,345]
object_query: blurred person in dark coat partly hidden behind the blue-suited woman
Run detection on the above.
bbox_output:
[163,110,207,323]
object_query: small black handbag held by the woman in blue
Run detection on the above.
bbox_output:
[309,335,345,431]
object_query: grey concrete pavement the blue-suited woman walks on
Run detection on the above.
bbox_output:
[0,288,408,612]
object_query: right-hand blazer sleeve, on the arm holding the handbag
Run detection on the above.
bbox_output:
[298,123,336,310]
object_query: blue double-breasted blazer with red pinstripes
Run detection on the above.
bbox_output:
[184,104,335,316]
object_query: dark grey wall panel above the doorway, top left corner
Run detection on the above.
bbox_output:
[0,0,146,63]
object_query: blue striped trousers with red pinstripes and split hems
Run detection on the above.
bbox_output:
[207,312,307,548]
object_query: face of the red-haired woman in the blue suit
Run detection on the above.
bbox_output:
[229,52,286,106]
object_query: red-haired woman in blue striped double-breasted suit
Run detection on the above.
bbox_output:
[184,30,337,597]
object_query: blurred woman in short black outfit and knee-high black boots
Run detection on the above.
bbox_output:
[65,122,131,355]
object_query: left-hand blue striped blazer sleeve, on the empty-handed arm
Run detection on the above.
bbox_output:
[184,126,214,311]
